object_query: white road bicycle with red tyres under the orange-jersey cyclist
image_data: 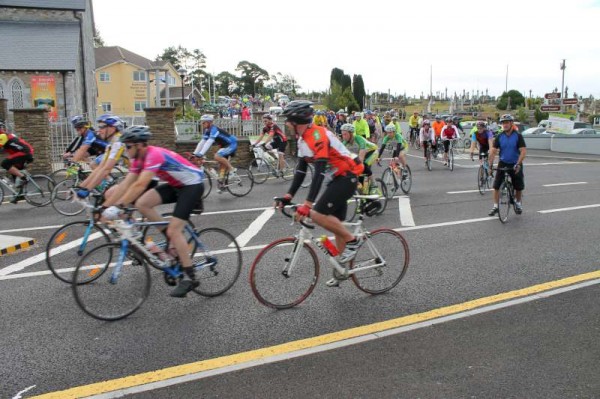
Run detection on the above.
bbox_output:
[250,196,410,309]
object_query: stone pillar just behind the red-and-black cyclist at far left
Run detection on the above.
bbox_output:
[11,108,52,174]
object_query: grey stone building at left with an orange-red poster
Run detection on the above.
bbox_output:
[0,0,96,119]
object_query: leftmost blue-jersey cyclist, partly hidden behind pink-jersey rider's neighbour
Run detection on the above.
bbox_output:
[63,115,108,169]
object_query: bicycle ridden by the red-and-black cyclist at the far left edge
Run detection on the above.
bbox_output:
[0,169,54,207]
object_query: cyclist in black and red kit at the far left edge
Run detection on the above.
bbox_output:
[0,119,33,200]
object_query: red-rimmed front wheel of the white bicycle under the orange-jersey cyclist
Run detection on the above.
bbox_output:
[250,237,319,309]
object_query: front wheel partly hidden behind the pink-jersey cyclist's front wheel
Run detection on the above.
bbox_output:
[46,220,110,284]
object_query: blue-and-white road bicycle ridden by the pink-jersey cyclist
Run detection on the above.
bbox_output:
[72,209,242,321]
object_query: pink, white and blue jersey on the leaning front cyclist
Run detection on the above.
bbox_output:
[129,146,204,188]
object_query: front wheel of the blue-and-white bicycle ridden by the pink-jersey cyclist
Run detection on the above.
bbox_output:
[73,243,151,321]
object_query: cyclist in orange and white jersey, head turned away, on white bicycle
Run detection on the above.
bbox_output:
[280,100,368,278]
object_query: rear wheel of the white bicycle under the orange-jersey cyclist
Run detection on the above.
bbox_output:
[350,228,410,295]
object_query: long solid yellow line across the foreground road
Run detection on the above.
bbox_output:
[34,270,600,399]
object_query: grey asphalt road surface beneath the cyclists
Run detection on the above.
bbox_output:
[0,151,600,398]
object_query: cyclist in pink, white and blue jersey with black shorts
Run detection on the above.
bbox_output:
[102,126,204,298]
